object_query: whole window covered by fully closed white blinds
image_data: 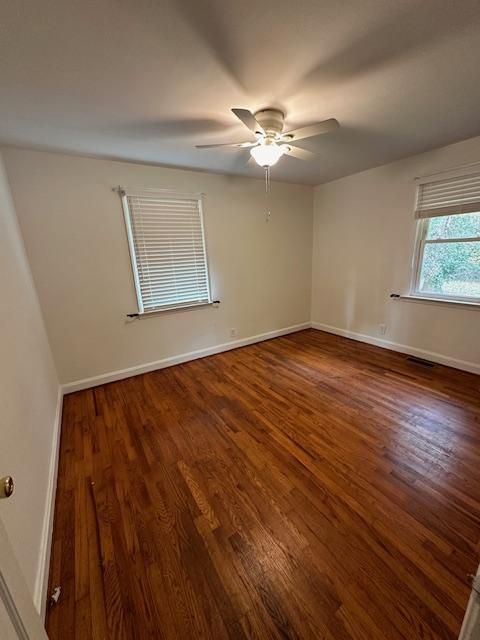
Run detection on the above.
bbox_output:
[121,189,211,313]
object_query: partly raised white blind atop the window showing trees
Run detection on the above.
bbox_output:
[415,173,480,219]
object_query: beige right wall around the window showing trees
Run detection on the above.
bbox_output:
[312,138,480,372]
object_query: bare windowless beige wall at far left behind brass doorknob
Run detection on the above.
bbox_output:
[0,158,58,596]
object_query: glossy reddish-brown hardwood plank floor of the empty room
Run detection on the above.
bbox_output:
[47,330,480,640]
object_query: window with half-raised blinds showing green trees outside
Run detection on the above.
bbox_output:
[412,173,480,302]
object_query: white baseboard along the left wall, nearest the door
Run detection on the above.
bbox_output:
[33,386,63,620]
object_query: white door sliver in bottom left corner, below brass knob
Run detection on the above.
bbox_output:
[0,492,48,640]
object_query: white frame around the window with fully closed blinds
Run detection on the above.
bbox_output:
[118,187,213,316]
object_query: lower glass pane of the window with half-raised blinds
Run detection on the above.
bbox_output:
[419,242,480,298]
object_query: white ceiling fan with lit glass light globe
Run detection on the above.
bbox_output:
[196,109,339,169]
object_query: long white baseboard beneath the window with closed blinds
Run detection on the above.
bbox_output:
[63,322,311,394]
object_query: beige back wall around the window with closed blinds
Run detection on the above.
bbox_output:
[4,149,313,383]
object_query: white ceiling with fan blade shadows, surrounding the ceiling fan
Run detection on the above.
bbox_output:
[0,0,480,184]
